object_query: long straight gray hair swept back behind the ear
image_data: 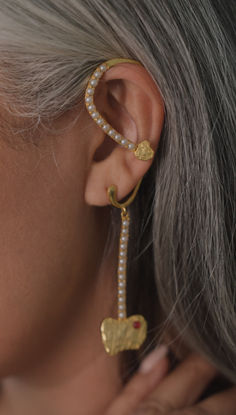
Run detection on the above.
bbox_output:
[0,0,236,382]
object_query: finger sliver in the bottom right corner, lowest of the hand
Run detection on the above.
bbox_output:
[197,387,236,415]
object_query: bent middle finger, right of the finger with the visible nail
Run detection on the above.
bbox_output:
[149,353,218,410]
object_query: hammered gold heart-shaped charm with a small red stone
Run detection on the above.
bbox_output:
[101,314,147,356]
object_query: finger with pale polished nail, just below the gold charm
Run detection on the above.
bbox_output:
[106,345,169,415]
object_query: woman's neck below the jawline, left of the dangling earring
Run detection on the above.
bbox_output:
[0,216,121,415]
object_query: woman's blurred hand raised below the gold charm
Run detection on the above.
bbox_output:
[105,348,236,415]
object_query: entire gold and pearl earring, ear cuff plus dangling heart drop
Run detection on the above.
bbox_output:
[85,58,154,355]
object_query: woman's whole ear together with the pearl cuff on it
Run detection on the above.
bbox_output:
[85,60,164,206]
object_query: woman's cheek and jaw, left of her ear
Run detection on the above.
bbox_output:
[0,144,87,377]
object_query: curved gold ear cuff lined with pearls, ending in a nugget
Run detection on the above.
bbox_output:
[85,58,154,160]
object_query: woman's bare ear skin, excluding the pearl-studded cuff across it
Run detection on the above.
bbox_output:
[85,63,164,206]
